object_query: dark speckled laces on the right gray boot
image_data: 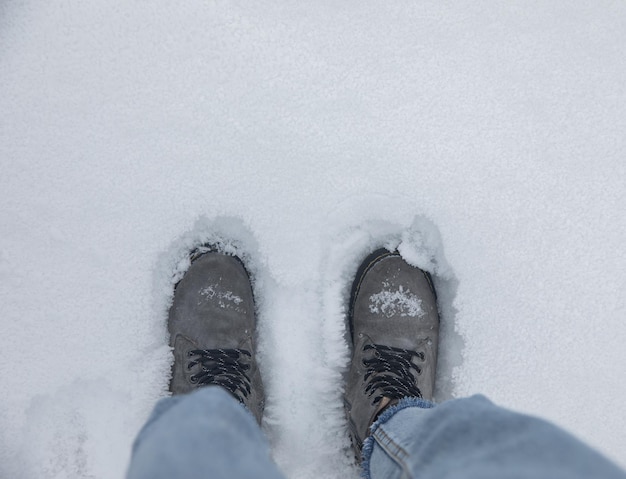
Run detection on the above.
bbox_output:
[363,344,424,405]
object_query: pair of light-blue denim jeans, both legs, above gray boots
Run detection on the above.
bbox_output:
[127,386,626,479]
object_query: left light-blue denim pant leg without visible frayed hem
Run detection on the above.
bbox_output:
[127,386,283,479]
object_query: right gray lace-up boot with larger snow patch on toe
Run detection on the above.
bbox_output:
[344,249,439,463]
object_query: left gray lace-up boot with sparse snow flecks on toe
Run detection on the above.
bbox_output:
[168,249,264,424]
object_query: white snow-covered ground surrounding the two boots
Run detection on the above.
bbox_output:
[0,0,626,478]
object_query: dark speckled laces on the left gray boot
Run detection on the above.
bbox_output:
[187,349,251,400]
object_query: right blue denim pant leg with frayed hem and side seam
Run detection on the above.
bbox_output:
[363,396,626,479]
